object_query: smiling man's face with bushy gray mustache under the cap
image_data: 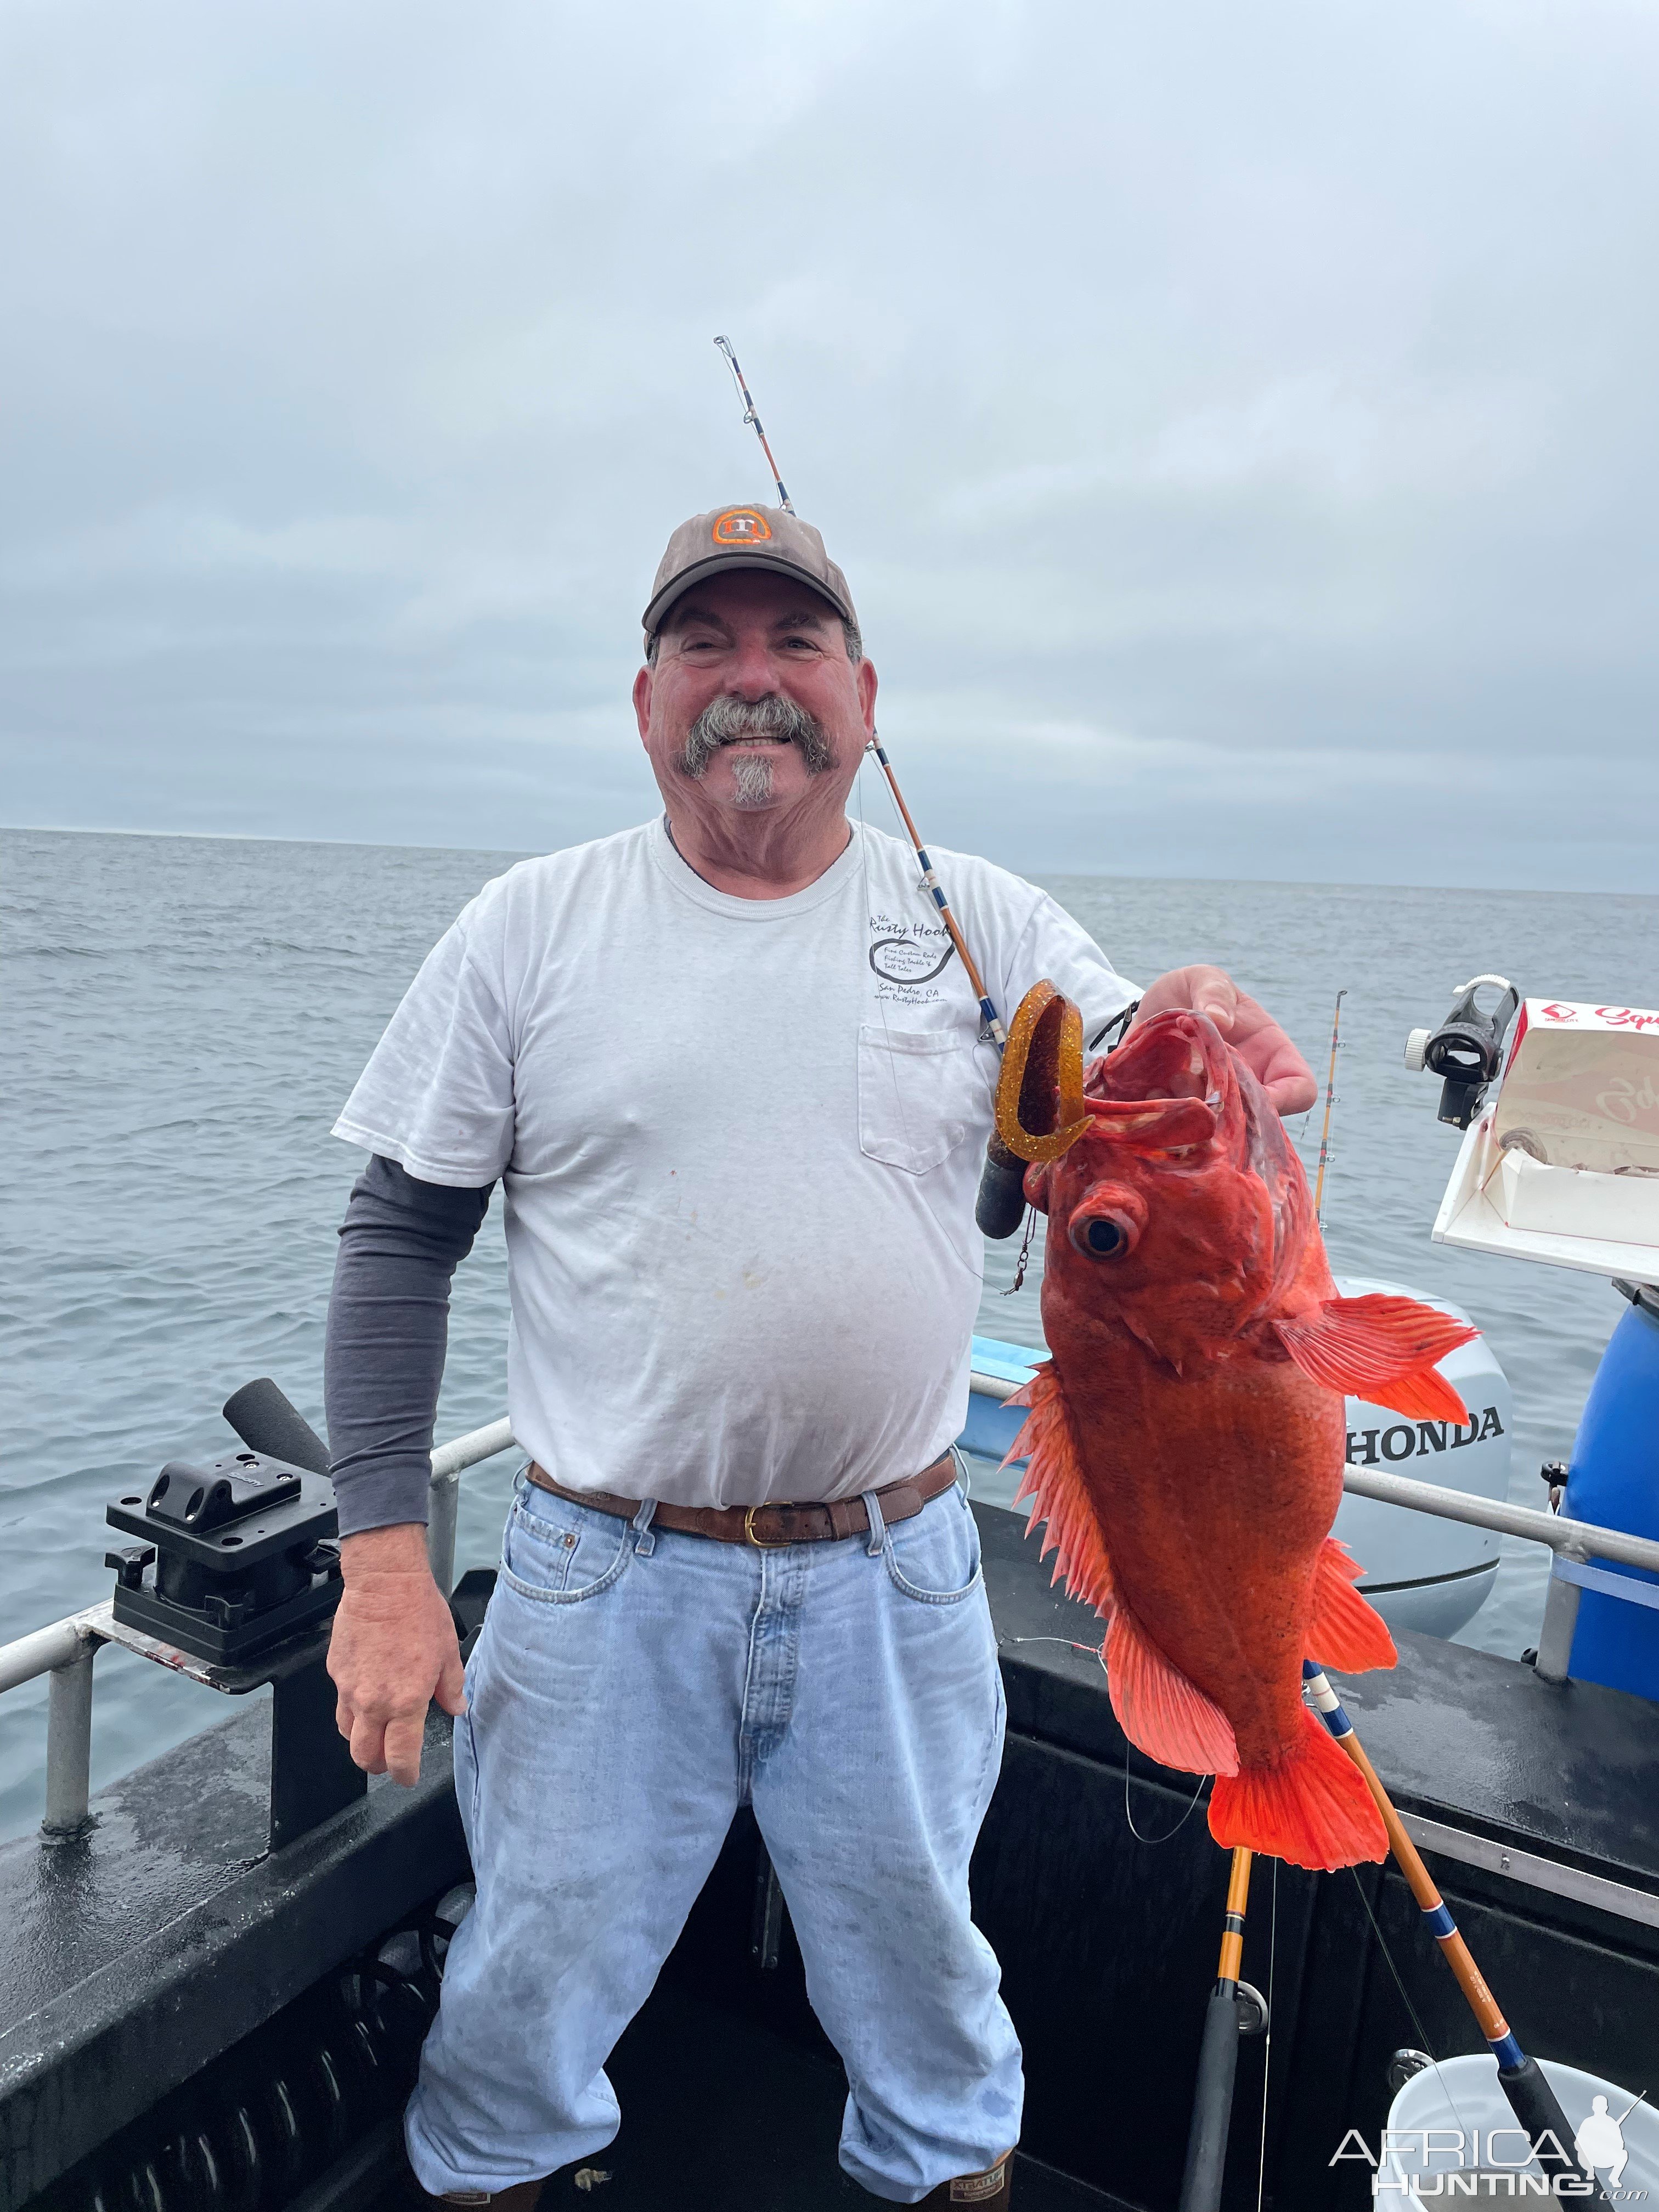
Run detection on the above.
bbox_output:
[633,568,876,819]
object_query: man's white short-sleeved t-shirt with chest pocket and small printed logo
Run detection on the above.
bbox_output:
[334,821,1132,1506]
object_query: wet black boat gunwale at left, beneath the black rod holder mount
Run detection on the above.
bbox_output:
[0,1690,469,2205]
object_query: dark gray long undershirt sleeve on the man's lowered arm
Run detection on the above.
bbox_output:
[323,1153,495,1535]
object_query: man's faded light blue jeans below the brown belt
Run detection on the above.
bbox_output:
[405,1484,1022,2203]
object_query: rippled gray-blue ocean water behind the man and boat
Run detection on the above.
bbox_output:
[0,808,1659,1836]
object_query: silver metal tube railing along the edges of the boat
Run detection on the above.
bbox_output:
[0,1374,1659,1843]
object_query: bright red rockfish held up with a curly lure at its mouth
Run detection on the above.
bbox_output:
[997,984,1475,1867]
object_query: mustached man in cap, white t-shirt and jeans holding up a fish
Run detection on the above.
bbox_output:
[328,506,1314,2208]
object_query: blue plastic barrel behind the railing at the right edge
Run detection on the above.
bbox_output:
[1562,1292,1659,1699]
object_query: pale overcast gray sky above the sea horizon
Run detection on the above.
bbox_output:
[0,0,1659,891]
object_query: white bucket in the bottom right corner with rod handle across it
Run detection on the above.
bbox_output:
[1376,2053,1659,2212]
